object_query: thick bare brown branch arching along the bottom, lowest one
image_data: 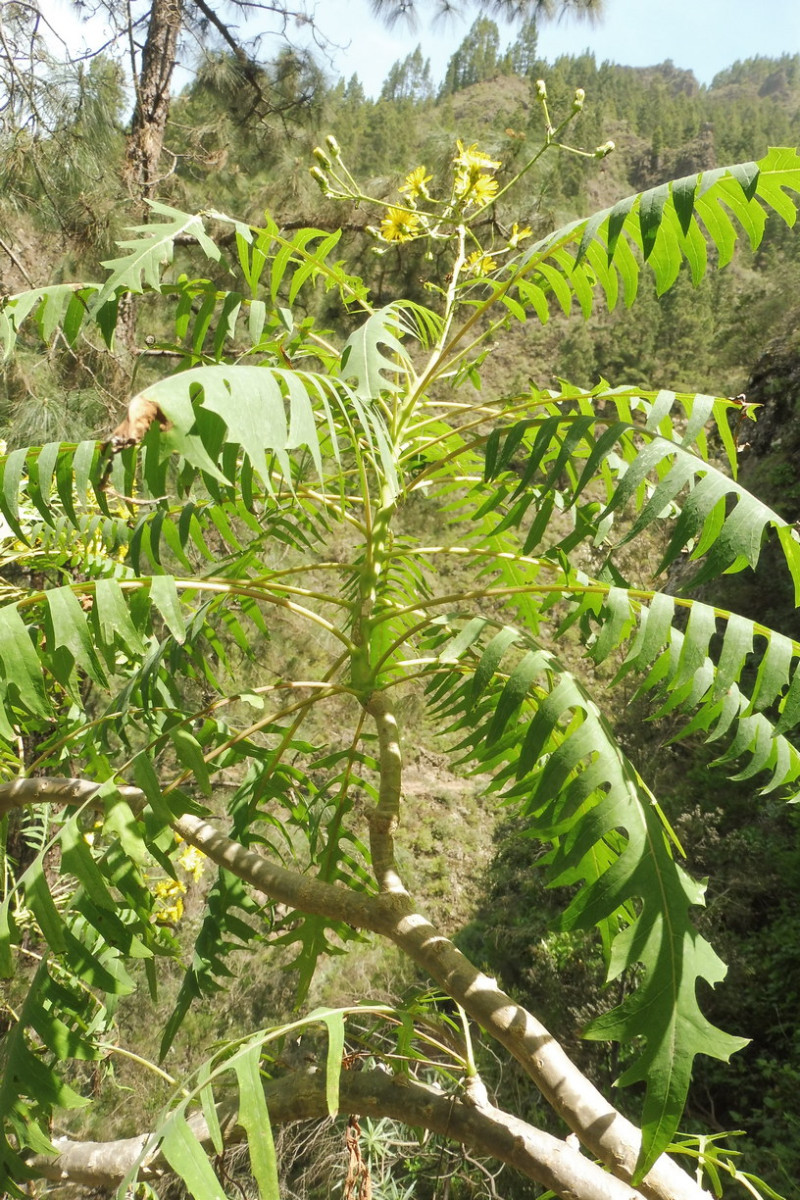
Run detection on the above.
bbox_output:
[30,1070,640,1200]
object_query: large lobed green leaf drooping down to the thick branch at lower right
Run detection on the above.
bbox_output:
[429,624,745,1177]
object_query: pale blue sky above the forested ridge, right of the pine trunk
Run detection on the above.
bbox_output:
[317,0,800,95]
